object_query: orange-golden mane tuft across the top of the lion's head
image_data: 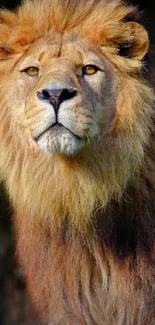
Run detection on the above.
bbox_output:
[0,0,148,61]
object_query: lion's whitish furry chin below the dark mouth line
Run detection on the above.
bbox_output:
[36,125,85,156]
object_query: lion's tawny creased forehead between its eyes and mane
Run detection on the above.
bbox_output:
[20,37,103,71]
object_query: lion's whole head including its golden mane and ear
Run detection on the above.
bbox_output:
[0,0,153,227]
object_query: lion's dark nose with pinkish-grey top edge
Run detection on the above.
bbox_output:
[37,88,77,111]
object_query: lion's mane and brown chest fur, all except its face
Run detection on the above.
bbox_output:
[0,0,155,325]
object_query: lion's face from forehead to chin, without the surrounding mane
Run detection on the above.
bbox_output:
[6,38,116,155]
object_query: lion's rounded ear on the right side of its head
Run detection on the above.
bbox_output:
[115,22,149,60]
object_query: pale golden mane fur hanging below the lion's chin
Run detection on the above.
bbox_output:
[8,138,144,230]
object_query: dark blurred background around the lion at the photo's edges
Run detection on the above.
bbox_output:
[0,0,155,325]
